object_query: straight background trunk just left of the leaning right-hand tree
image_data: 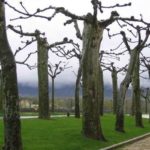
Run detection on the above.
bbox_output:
[111,68,118,114]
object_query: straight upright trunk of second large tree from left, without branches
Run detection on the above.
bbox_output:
[37,37,50,119]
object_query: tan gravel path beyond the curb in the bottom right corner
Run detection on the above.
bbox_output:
[118,136,150,150]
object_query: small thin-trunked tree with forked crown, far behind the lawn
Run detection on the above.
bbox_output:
[48,61,71,112]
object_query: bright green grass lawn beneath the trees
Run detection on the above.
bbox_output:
[0,115,150,150]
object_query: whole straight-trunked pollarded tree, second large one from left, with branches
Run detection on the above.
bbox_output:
[8,25,73,119]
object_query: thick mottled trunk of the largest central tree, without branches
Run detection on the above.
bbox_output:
[82,22,104,140]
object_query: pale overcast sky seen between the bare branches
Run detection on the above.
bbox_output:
[6,0,150,84]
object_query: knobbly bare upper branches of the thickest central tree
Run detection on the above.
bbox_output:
[5,0,150,27]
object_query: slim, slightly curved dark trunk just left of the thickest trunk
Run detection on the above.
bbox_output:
[75,60,82,118]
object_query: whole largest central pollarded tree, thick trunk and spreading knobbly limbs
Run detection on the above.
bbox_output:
[6,0,150,140]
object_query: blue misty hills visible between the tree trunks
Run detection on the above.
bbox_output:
[19,83,112,98]
